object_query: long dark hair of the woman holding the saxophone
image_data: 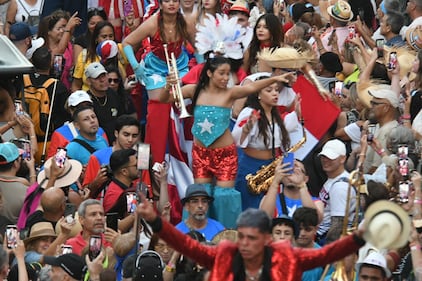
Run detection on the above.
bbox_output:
[245,77,290,151]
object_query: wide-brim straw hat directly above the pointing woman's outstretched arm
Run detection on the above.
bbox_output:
[258,47,313,69]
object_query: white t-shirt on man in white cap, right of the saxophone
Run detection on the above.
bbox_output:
[318,171,356,235]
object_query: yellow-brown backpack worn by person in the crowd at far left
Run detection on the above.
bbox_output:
[18,74,57,137]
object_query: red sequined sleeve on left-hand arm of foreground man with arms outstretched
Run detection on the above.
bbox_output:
[158,220,217,269]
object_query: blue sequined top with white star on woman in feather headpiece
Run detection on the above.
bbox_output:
[192,105,231,147]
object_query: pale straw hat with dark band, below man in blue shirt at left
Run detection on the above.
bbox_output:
[37,157,82,188]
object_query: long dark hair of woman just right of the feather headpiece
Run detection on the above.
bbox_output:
[247,14,284,70]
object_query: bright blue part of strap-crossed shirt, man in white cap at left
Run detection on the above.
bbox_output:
[66,135,108,165]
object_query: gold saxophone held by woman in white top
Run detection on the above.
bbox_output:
[245,119,306,194]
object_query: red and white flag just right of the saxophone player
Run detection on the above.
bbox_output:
[285,75,340,160]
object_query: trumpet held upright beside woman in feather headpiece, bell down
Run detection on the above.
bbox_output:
[163,44,192,118]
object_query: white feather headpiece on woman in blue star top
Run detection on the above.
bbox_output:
[195,14,250,59]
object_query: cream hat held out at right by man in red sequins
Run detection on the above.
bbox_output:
[363,200,411,249]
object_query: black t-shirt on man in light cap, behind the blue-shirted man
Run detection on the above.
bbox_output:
[88,88,133,143]
